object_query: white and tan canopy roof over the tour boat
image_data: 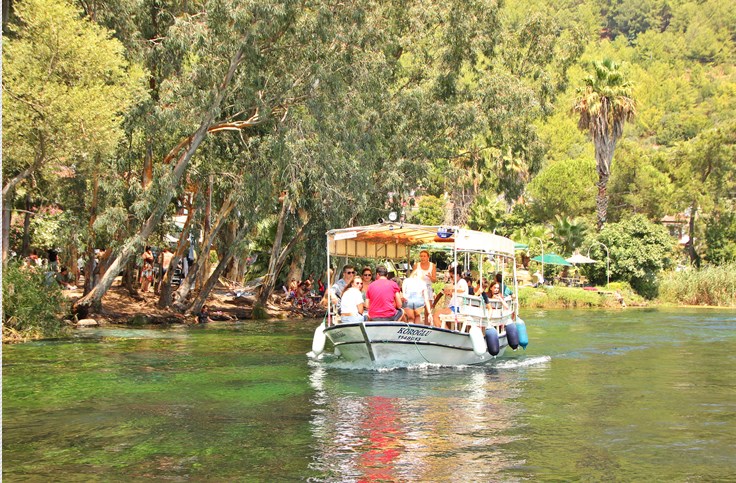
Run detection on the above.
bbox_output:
[327,223,514,259]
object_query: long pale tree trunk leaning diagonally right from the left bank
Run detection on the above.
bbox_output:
[74,47,249,310]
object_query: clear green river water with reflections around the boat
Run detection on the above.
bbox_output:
[2,309,736,482]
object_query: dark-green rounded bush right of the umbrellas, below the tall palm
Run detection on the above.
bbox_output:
[589,215,674,298]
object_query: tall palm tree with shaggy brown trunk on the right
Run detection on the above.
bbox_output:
[573,59,636,231]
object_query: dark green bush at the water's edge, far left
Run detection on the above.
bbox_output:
[3,263,66,340]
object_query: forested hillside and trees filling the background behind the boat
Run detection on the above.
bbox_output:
[3,0,736,318]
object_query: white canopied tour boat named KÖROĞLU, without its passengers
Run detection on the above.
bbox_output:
[308,222,528,366]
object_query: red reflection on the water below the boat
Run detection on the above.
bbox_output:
[358,396,404,482]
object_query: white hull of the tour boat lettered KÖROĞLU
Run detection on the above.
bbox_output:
[324,322,508,366]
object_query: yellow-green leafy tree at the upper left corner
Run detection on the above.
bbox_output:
[3,0,142,260]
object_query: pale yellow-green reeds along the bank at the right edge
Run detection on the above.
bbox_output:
[658,263,736,307]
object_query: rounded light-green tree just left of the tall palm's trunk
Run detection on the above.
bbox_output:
[527,159,596,221]
